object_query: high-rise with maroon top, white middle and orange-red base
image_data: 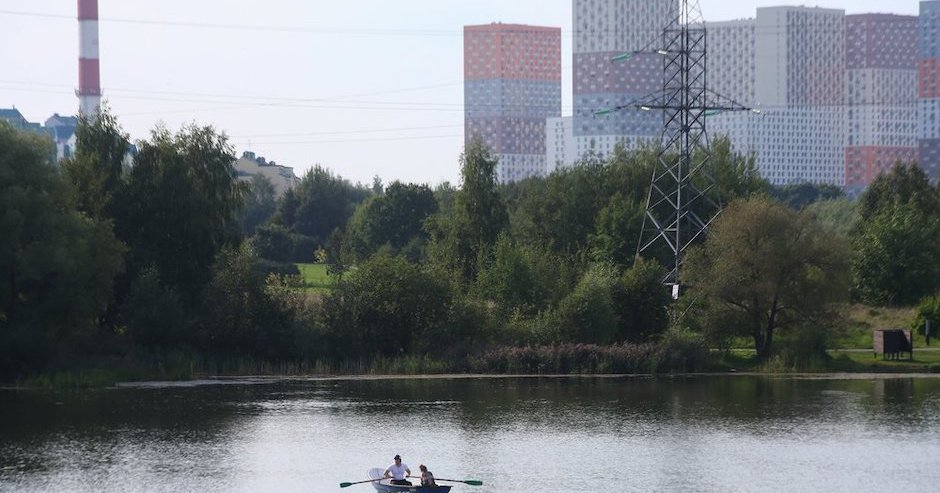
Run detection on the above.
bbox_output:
[845,14,917,193]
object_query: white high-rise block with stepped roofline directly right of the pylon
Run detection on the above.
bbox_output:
[706,7,846,186]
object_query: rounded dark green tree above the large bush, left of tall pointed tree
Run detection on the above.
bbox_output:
[345,181,437,261]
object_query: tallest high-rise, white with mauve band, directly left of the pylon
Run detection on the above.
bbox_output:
[572,0,679,161]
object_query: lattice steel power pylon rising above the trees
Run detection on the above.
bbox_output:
[595,0,758,297]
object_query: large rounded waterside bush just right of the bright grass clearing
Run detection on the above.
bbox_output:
[323,255,458,357]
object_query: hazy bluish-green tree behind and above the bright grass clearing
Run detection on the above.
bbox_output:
[273,165,369,244]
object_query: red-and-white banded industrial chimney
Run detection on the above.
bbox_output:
[77,0,101,118]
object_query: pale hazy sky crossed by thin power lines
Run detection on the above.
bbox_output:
[0,0,919,186]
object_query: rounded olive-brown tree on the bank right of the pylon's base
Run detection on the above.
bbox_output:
[681,197,849,359]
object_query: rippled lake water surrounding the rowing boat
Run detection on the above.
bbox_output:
[0,375,940,493]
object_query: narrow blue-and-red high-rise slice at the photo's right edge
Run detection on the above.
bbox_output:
[917,1,940,180]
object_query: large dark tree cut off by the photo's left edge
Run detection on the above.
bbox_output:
[0,122,124,375]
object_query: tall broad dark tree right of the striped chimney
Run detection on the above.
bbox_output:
[115,126,244,305]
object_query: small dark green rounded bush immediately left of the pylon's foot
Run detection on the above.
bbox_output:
[613,257,672,342]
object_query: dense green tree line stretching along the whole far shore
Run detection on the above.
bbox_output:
[0,112,940,377]
